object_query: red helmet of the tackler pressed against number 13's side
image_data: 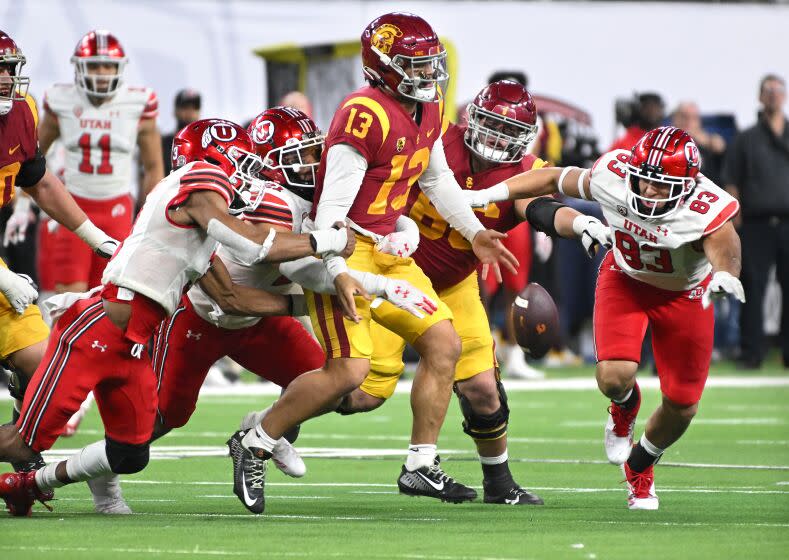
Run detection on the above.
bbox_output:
[247,107,326,200]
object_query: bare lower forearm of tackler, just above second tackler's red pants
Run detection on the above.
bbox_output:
[199,257,293,317]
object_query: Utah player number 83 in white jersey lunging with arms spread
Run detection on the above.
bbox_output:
[469,126,745,509]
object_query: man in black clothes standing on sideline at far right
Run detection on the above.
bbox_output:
[723,74,789,369]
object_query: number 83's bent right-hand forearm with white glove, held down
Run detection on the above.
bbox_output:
[701,221,745,309]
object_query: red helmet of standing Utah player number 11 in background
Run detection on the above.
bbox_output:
[71,30,128,97]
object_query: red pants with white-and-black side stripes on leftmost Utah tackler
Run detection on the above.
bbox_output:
[16,296,156,451]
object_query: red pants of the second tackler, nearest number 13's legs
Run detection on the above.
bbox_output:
[153,296,325,429]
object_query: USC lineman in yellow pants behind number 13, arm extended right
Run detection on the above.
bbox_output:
[340,81,608,505]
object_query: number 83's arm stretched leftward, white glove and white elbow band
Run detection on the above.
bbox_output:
[463,167,591,208]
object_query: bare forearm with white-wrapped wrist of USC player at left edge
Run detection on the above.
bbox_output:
[24,167,118,258]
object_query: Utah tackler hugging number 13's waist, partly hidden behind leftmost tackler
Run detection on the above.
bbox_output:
[88,107,438,513]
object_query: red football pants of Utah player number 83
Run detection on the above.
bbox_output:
[594,252,715,405]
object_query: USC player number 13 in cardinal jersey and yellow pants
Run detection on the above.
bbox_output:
[225,13,517,513]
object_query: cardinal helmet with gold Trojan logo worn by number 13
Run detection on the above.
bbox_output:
[362,12,449,103]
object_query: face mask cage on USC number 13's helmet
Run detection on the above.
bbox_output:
[383,48,449,103]
